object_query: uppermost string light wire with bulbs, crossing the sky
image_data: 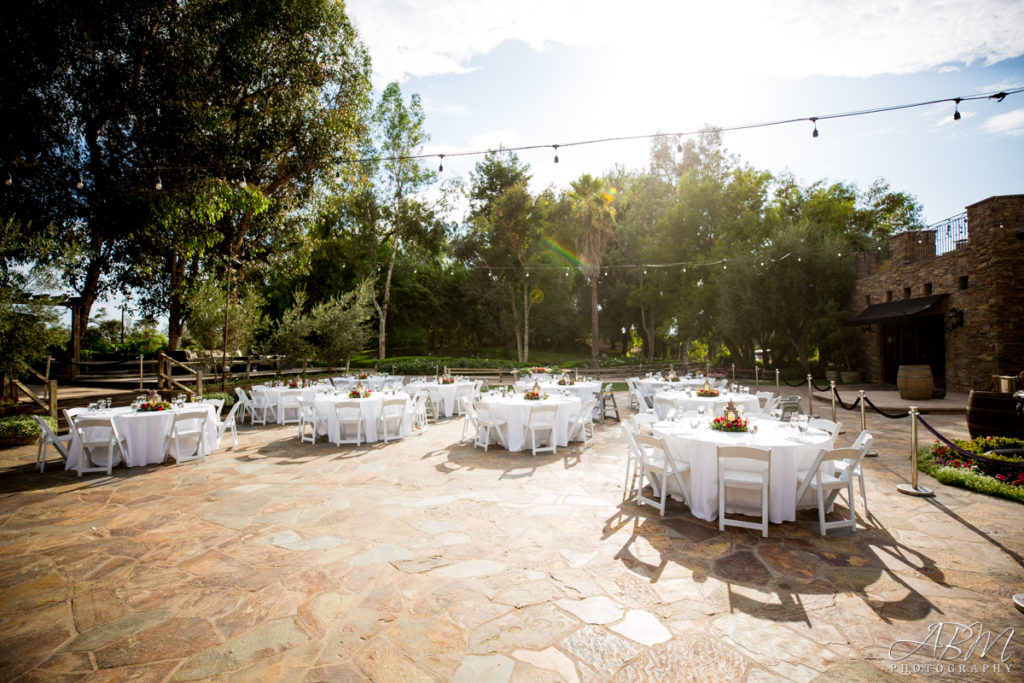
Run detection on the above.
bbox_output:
[6,87,1024,178]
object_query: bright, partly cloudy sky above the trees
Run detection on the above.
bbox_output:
[346,0,1024,223]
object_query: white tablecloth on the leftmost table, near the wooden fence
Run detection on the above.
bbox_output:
[65,403,218,470]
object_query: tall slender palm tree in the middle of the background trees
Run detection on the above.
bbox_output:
[569,173,615,368]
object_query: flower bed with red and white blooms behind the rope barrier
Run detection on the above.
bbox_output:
[918,436,1024,503]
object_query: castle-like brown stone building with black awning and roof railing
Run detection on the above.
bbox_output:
[847,195,1024,391]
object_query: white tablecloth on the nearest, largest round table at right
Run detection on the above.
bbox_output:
[653,420,834,524]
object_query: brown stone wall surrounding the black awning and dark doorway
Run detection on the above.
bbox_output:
[849,195,1024,391]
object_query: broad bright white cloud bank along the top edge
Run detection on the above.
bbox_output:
[346,0,1024,83]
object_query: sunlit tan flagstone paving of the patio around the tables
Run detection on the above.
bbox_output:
[0,394,1024,681]
